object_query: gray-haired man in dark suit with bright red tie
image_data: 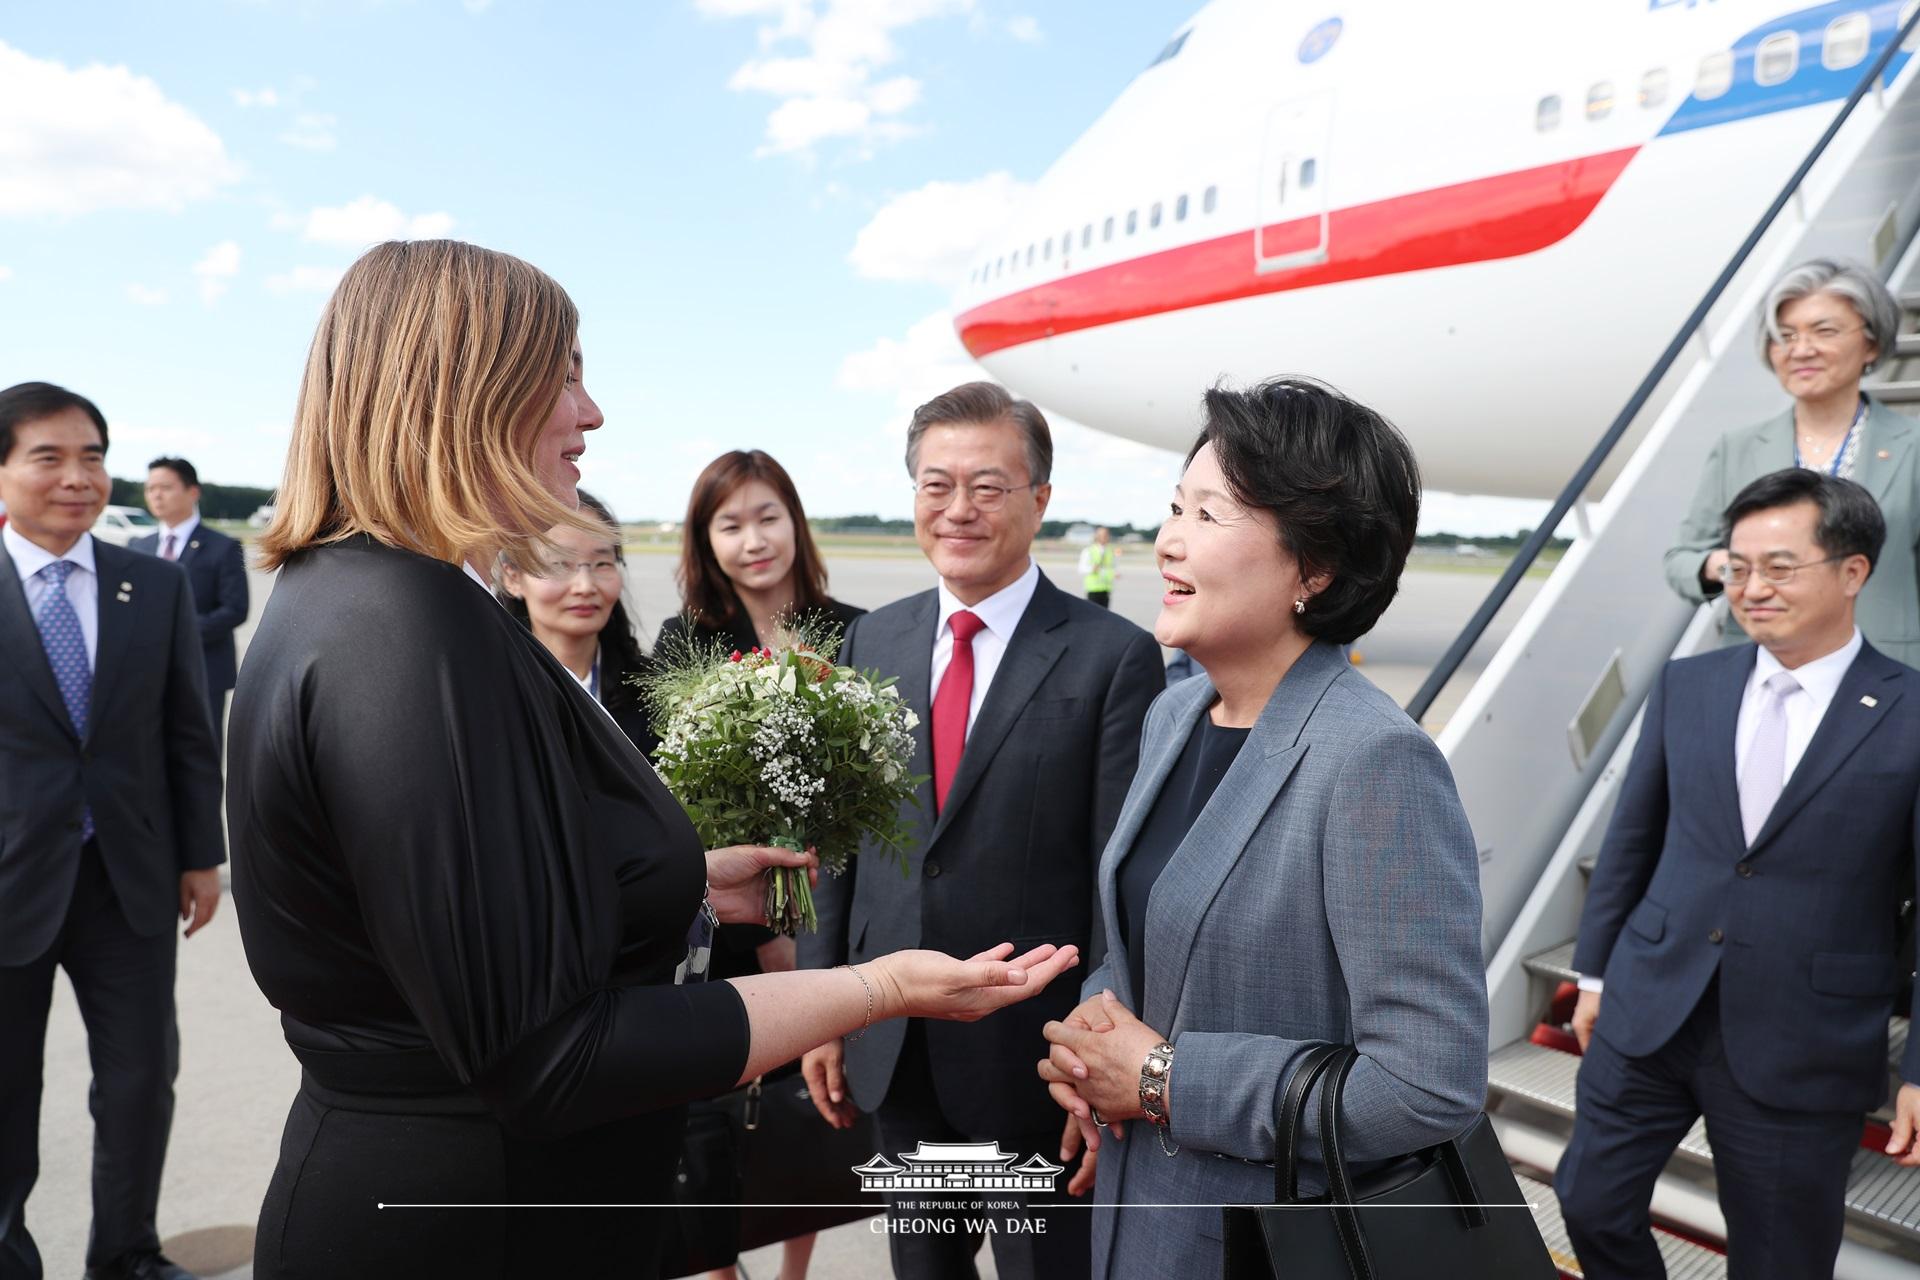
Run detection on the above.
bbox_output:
[799,382,1165,1280]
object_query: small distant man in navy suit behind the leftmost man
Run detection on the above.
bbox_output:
[127,459,248,747]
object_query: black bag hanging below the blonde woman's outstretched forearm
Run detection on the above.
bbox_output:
[660,1075,887,1276]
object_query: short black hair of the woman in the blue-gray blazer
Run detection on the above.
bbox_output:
[1187,378,1421,645]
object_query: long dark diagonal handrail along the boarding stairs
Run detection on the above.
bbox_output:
[1407,6,1920,720]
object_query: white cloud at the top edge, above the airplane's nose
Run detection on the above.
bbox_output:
[697,0,973,155]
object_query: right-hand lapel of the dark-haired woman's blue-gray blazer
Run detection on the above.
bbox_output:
[1140,641,1346,1034]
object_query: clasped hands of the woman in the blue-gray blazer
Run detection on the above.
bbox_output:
[1039,990,1164,1196]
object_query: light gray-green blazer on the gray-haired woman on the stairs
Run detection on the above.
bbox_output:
[1667,399,1920,666]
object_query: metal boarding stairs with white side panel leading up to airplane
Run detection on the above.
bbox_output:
[1407,17,1920,1280]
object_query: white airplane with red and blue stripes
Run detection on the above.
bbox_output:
[954,0,1920,497]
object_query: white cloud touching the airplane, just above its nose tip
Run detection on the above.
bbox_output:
[847,173,1031,284]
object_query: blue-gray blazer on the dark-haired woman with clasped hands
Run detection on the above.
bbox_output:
[1083,641,1488,1280]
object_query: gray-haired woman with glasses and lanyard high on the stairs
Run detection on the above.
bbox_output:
[1667,257,1920,666]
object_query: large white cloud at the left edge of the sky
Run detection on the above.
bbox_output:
[0,42,238,217]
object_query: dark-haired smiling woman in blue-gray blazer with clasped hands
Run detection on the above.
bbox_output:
[1039,380,1486,1280]
